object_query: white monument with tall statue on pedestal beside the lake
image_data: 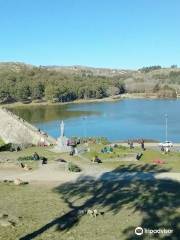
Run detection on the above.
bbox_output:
[55,121,72,152]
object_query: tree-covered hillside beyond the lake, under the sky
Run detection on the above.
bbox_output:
[0,62,180,103]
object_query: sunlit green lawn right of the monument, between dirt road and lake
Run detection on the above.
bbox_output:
[83,144,180,172]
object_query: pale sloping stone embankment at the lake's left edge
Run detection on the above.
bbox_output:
[0,108,56,145]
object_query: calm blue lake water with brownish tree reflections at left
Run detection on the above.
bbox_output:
[9,99,180,142]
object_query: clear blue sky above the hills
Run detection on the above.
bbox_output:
[0,0,180,68]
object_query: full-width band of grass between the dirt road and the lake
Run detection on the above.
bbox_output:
[0,144,180,172]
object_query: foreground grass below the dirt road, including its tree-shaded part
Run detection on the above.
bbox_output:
[0,174,180,240]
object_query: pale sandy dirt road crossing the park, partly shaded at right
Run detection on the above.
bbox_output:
[0,160,180,184]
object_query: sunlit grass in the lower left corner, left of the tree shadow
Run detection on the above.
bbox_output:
[0,184,70,240]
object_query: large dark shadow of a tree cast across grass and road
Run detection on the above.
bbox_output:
[20,164,180,240]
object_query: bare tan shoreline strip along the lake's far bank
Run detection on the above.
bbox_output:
[0,93,178,108]
